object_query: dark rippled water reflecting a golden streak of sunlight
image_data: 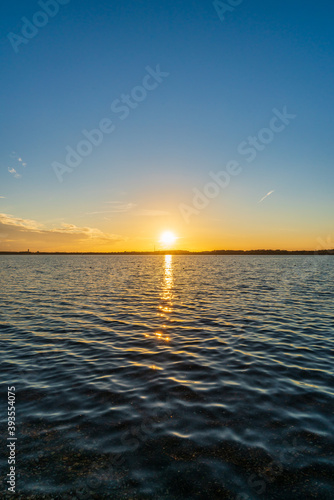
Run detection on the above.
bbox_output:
[0,256,334,500]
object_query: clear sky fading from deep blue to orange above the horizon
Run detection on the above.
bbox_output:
[0,0,334,252]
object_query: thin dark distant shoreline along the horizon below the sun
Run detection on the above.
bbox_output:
[0,249,334,256]
